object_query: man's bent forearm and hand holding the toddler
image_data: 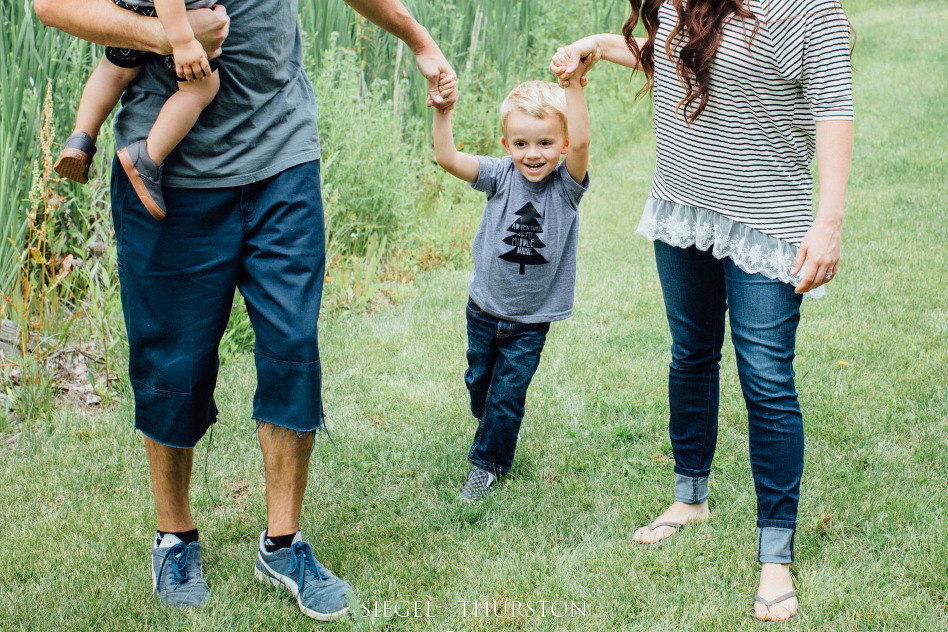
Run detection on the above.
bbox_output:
[33,0,230,57]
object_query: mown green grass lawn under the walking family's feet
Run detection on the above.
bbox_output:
[0,0,948,632]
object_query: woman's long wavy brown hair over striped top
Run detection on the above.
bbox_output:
[622,0,760,123]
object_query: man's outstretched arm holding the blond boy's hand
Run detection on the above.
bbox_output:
[345,0,458,110]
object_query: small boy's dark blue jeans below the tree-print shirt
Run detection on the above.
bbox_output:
[464,299,550,476]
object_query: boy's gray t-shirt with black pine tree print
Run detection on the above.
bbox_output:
[468,156,589,323]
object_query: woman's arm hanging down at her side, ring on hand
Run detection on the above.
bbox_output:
[790,120,853,294]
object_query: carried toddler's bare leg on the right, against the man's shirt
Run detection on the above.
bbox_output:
[147,70,220,165]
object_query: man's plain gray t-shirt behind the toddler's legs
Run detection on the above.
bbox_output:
[114,0,320,188]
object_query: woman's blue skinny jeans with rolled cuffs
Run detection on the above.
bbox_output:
[655,241,803,564]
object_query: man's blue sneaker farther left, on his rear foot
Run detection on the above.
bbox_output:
[151,533,210,608]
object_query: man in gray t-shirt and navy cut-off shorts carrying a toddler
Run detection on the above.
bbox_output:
[35,0,456,620]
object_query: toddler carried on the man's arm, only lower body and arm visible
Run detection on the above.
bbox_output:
[53,0,220,220]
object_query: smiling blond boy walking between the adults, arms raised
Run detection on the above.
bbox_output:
[434,81,590,502]
